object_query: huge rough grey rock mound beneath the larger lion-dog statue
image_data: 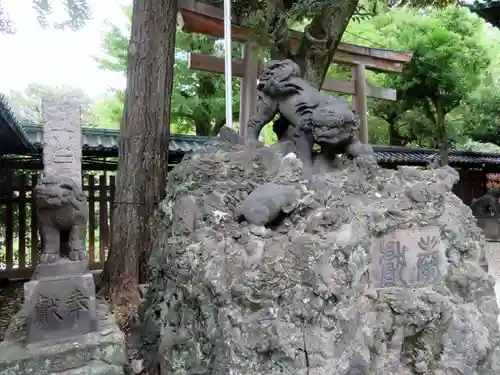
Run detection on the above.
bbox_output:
[140,130,500,375]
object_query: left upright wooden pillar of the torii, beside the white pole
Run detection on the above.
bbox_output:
[240,42,259,139]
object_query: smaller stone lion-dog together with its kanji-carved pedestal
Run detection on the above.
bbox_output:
[18,175,98,343]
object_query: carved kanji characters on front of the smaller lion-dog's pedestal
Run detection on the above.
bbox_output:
[35,289,89,328]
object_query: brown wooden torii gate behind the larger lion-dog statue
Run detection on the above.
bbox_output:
[178,0,413,143]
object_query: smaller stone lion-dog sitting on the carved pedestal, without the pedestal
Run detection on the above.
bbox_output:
[35,176,89,264]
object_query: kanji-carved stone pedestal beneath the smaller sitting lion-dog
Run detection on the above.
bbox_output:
[24,261,97,343]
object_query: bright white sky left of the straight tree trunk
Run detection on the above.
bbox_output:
[0,0,130,97]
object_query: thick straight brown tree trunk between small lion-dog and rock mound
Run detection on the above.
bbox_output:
[100,0,178,303]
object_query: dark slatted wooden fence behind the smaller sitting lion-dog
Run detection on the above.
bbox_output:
[0,170,115,279]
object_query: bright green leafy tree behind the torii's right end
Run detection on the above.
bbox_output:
[344,7,490,160]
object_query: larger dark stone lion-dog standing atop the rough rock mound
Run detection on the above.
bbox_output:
[248,60,375,166]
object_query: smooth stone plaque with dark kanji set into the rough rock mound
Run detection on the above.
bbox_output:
[370,227,446,288]
